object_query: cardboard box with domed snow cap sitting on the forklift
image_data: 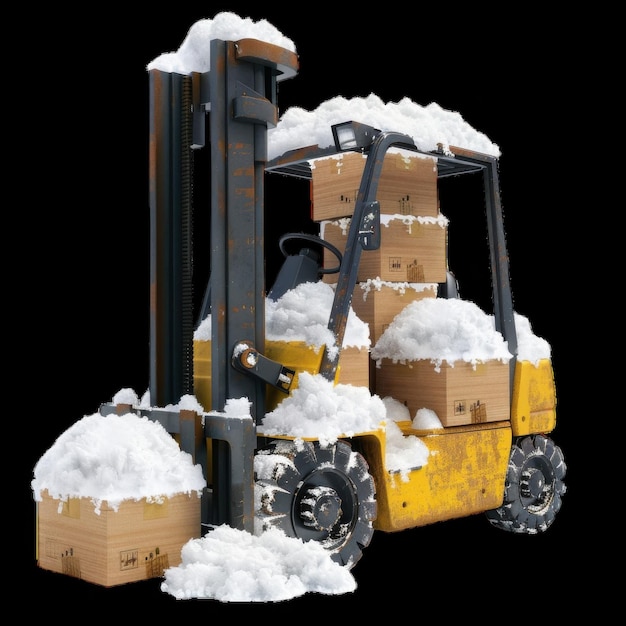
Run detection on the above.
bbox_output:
[371,298,511,426]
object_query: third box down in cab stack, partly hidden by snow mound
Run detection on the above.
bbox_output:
[352,280,437,345]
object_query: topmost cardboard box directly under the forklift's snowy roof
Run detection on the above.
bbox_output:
[311,150,439,222]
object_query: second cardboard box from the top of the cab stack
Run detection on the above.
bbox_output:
[320,214,448,283]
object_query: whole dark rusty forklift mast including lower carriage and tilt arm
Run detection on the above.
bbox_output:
[100,39,298,534]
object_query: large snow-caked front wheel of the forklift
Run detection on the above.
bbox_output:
[255,440,377,569]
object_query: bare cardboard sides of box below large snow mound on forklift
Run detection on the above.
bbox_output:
[375,359,510,426]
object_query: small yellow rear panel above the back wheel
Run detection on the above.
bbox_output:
[511,359,556,437]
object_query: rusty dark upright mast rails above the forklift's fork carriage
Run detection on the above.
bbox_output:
[150,39,298,421]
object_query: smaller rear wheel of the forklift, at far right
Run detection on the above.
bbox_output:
[486,435,567,535]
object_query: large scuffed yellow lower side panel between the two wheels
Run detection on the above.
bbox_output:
[362,421,511,532]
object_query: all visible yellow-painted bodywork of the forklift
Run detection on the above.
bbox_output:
[194,341,556,532]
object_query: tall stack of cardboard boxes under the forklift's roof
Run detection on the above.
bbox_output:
[311,150,448,398]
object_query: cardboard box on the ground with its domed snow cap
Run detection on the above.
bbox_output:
[32,413,206,587]
